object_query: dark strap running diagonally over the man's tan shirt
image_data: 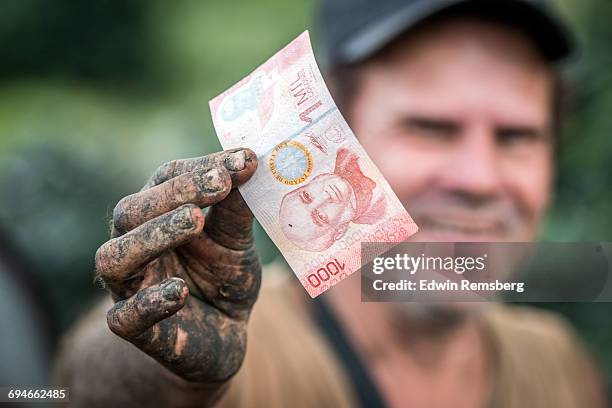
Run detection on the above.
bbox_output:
[314,296,385,408]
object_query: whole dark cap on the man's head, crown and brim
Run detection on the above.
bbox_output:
[318,0,573,66]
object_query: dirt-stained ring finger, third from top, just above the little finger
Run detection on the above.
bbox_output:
[96,204,204,283]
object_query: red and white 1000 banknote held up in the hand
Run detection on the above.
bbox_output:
[210,31,417,297]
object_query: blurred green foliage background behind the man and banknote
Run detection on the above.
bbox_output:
[0,0,612,380]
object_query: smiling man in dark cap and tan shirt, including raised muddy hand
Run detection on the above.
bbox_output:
[57,0,602,408]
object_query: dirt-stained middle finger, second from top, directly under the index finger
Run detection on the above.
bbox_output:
[113,167,232,236]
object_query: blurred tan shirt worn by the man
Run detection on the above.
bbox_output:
[219,265,603,408]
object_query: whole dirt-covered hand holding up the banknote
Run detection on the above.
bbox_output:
[96,149,261,383]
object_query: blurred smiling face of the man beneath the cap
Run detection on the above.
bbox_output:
[347,20,553,242]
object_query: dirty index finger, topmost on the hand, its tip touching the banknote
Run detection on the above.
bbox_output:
[142,147,257,190]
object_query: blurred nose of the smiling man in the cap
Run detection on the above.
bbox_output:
[440,126,502,200]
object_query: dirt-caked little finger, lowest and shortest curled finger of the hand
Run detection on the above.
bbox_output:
[106,278,189,340]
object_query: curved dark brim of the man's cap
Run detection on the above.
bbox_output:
[336,0,574,64]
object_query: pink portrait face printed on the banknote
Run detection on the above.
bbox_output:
[279,173,355,251]
